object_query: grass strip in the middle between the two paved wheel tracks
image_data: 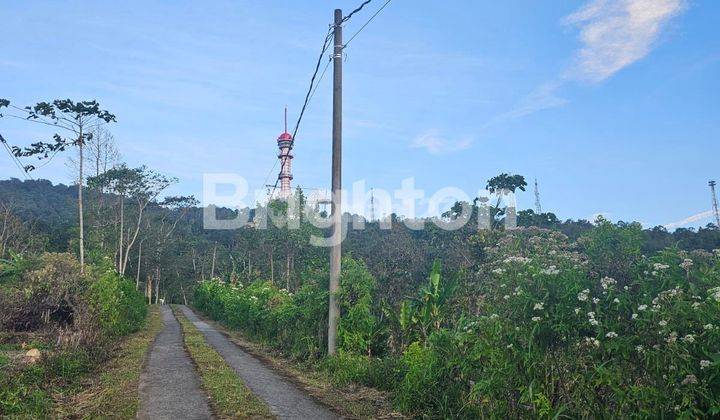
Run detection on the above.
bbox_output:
[173,308,275,419]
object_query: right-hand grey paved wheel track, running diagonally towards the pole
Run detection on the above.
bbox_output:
[180,306,338,419]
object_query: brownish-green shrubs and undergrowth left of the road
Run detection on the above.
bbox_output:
[0,253,146,417]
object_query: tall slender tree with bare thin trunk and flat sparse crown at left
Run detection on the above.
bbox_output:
[0,99,116,273]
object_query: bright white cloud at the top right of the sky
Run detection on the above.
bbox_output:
[564,0,684,82]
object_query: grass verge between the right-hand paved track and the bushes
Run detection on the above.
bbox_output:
[188,309,406,419]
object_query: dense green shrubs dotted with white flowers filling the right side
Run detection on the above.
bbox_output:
[404,231,720,418]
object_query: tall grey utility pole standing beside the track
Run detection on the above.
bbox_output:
[328,9,343,355]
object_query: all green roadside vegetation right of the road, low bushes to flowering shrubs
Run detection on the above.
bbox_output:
[195,220,720,417]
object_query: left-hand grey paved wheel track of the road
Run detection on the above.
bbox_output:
[138,306,212,419]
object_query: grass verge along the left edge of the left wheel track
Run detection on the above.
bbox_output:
[54,306,163,419]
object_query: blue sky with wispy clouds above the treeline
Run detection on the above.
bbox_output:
[0,0,720,227]
